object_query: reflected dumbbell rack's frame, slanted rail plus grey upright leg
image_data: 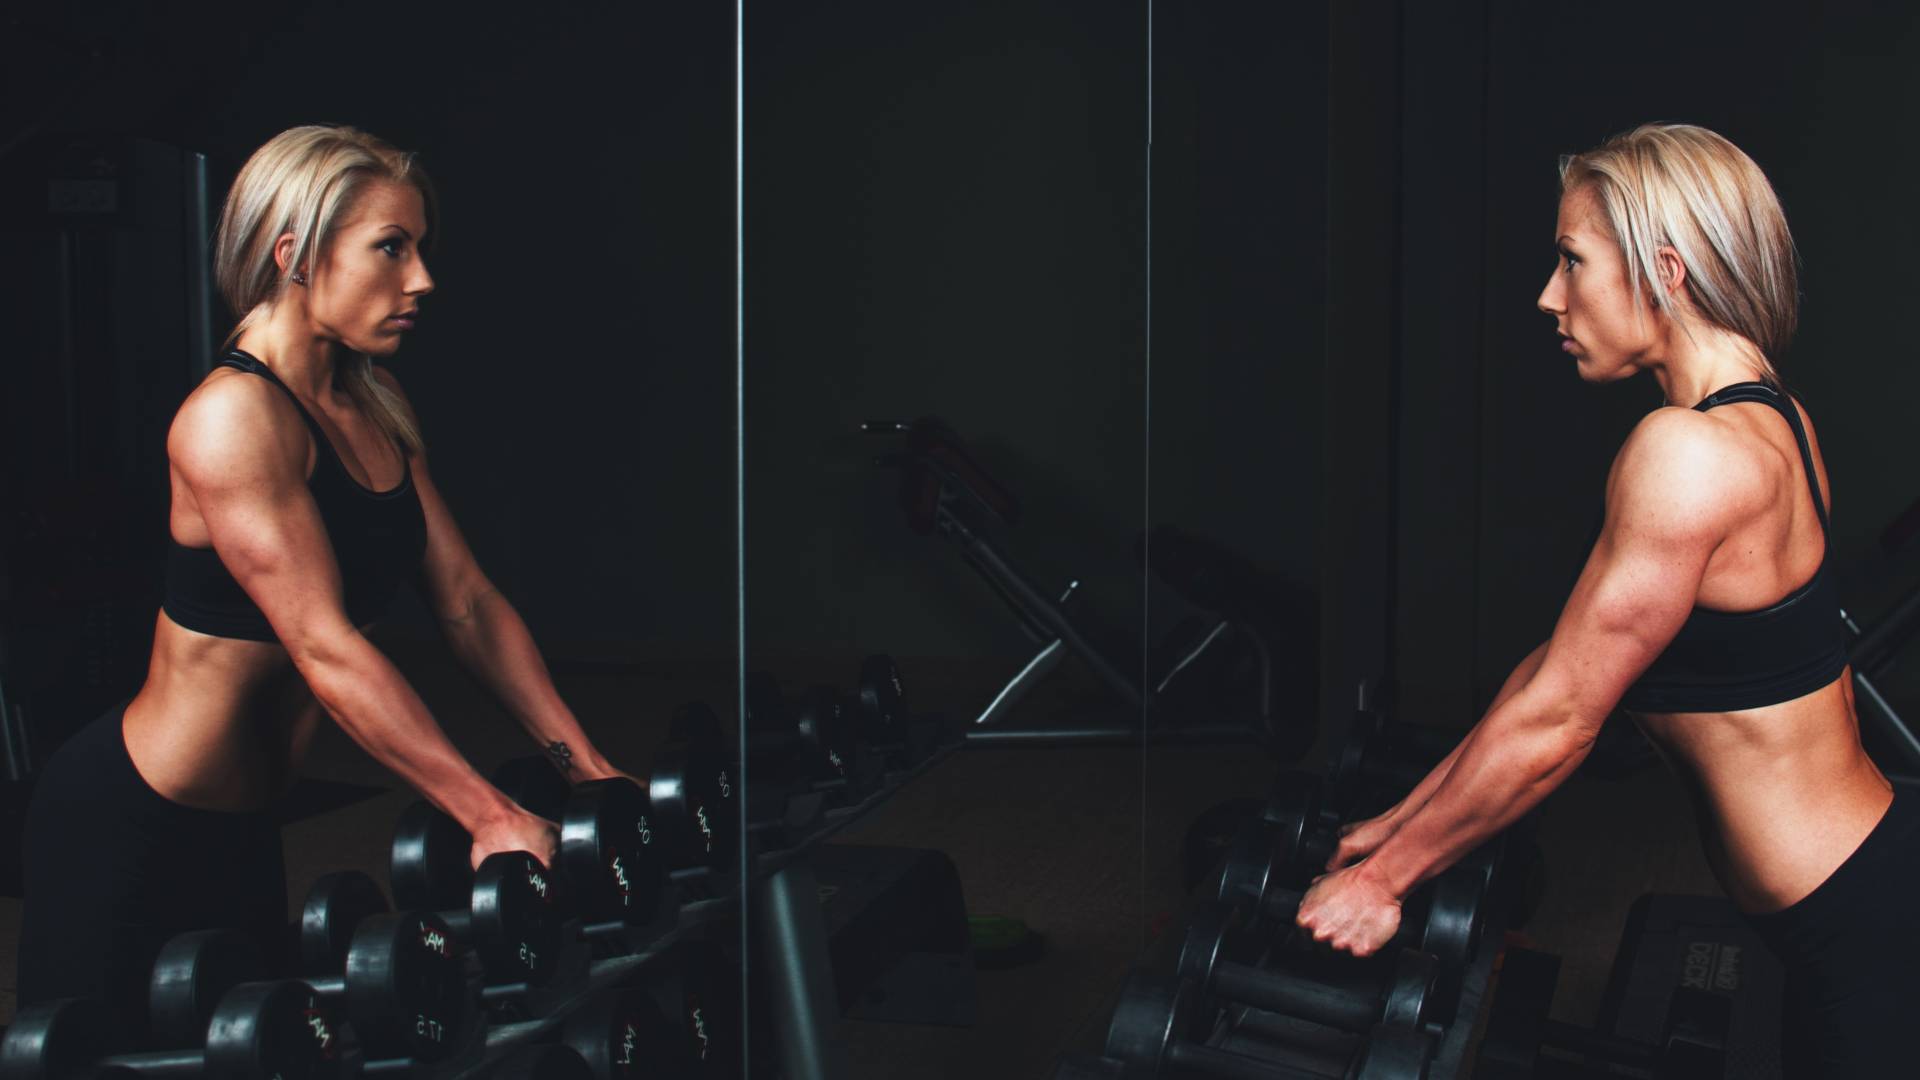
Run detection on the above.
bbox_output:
[409,718,972,1080]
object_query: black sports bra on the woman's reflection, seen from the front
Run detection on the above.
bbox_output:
[163,350,426,642]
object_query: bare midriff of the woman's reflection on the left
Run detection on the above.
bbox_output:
[123,613,351,811]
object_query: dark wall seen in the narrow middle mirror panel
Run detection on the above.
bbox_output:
[745,0,1146,655]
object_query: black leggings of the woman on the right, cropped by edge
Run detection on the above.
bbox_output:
[1747,790,1920,1080]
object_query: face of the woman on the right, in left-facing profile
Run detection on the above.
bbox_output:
[1538,186,1659,382]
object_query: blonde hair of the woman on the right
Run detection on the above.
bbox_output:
[1559,123,1799,386]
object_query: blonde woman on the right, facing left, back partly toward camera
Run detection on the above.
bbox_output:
[1300,125,1920,1076]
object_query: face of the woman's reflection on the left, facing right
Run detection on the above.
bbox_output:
[294,181,434,356]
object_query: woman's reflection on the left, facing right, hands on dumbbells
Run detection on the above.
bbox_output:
[19,127,629,1030]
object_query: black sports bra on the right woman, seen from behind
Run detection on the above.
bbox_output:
[1620,382,1847,713]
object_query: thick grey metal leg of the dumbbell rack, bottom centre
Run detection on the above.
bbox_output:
[753,859,847,1080]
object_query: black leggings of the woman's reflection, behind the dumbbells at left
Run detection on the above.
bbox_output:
[19,703,286,1032]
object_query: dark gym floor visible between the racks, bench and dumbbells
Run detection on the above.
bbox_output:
[0,644,1718,1080]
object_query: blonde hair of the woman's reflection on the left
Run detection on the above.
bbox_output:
[213,125,438,454]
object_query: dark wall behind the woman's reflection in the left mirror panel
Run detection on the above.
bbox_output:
[0,4,735,714]
